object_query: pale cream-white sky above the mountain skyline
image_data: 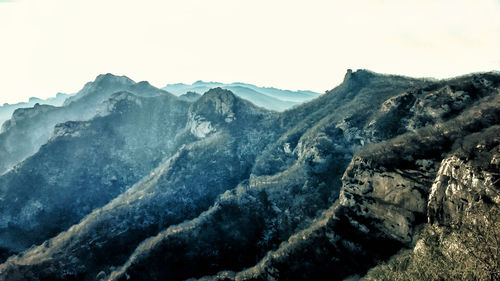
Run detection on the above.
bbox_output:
[0,0,500,104]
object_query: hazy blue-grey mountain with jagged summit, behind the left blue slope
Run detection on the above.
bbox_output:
[0,73,170,174]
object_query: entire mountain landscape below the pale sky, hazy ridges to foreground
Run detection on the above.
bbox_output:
[0,70,500,280]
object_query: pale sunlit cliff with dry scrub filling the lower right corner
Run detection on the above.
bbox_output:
[363,126,500,280]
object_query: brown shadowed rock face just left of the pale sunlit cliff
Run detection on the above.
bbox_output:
[340,158,436,243]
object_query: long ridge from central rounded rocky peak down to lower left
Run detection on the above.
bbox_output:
[0,89,275,280]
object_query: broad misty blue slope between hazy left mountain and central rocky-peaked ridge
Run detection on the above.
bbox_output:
[0,92,189,260]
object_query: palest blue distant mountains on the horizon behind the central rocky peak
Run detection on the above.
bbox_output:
[163,81,319,111]
